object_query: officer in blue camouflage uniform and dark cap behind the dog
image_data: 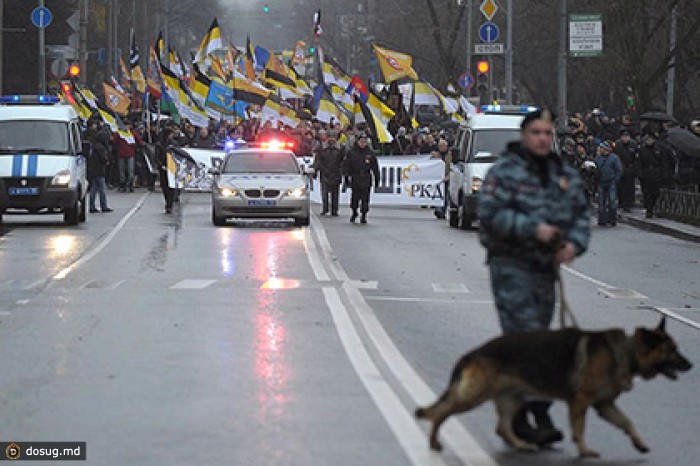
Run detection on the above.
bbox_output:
[477,110,590,445]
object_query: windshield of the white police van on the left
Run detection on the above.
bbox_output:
[0,120,70,154]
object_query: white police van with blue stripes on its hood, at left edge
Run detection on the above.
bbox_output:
[0,95,88,225]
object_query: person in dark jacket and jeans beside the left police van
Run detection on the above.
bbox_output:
[85,118,113,213]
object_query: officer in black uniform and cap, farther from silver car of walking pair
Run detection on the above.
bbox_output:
[345,133,380,223]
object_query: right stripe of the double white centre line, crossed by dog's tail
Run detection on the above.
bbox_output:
[311,216,498,466]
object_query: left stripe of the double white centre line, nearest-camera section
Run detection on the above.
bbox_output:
[323,287,446,466]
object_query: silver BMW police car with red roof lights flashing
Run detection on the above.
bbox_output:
[212,146,310,226]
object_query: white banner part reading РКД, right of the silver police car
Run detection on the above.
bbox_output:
[299,155,445,206]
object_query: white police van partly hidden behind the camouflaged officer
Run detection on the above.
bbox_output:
[447,105,537,229]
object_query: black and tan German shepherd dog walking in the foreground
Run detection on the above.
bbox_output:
[415,317,692,457]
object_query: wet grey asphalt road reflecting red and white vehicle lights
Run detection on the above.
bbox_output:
[0,194,700,466]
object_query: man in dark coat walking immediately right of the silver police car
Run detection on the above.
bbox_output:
[314,130,345,217]
